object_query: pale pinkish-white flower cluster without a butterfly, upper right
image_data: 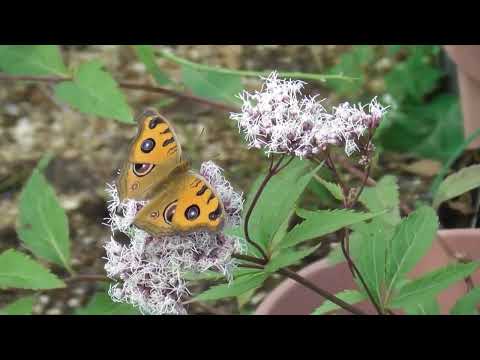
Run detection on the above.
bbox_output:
[230,72,386,158]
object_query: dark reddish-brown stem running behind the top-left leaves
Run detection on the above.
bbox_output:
[0,73,239,112]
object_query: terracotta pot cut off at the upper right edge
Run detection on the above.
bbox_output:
[444,45,480,149]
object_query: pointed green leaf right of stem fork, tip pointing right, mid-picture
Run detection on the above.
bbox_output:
[280,209,383,248]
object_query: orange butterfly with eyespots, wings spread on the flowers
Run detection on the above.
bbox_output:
[117,109,225,236]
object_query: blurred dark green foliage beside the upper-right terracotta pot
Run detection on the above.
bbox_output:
[327,45,463,161]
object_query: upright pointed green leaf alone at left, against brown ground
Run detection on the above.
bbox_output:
[17,162,71,271]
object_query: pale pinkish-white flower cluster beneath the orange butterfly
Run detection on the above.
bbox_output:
[101,161,244,315]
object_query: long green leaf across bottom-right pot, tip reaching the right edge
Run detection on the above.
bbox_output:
[389,262,480,308]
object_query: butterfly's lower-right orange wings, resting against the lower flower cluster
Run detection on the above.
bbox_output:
[134,171,225,236]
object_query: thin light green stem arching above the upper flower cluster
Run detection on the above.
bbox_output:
[158,50,358,82]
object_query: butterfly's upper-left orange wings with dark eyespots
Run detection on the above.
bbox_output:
[118,109,187,200]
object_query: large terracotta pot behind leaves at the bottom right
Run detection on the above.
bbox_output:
[255,229,480,315]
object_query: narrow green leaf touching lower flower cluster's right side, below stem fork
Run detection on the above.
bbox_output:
[195,271,269,301]
